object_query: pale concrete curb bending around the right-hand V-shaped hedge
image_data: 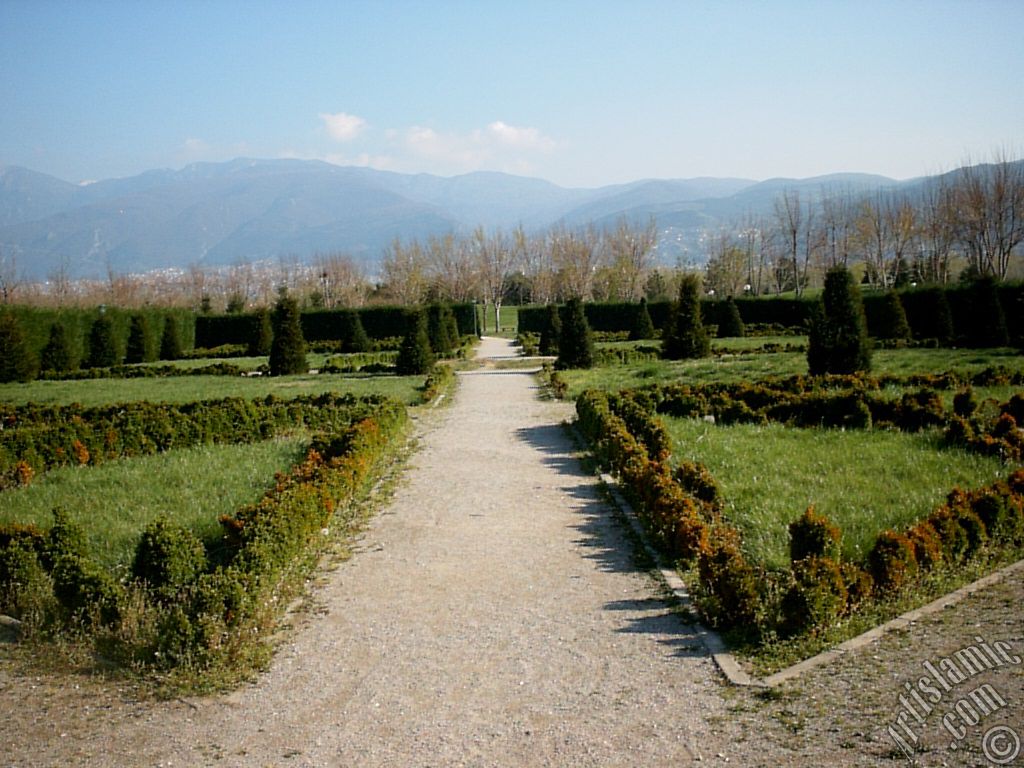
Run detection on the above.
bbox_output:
[589,448,1024,688]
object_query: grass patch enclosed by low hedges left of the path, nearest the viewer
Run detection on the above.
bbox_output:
[0,434,309,571]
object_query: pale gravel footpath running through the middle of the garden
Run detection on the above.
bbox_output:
[0,339,1024,768]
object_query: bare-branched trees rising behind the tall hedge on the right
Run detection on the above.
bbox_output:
[705,158,1024,296]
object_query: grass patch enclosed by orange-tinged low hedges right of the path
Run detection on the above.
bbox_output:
[665,419,1008,567]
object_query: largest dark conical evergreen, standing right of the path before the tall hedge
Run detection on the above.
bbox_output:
[807,266,871,376]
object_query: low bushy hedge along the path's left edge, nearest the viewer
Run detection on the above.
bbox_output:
[0,400,407,669]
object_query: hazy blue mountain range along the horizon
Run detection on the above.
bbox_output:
[0,159,909,280]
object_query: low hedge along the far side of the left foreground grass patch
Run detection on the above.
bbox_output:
[0,393,395,488]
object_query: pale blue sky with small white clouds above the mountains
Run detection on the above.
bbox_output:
[0,0,1024,187]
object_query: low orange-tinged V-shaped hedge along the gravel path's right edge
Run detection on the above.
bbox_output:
[577,390,1024,641]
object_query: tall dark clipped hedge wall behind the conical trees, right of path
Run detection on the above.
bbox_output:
[519,282,1024,347]
